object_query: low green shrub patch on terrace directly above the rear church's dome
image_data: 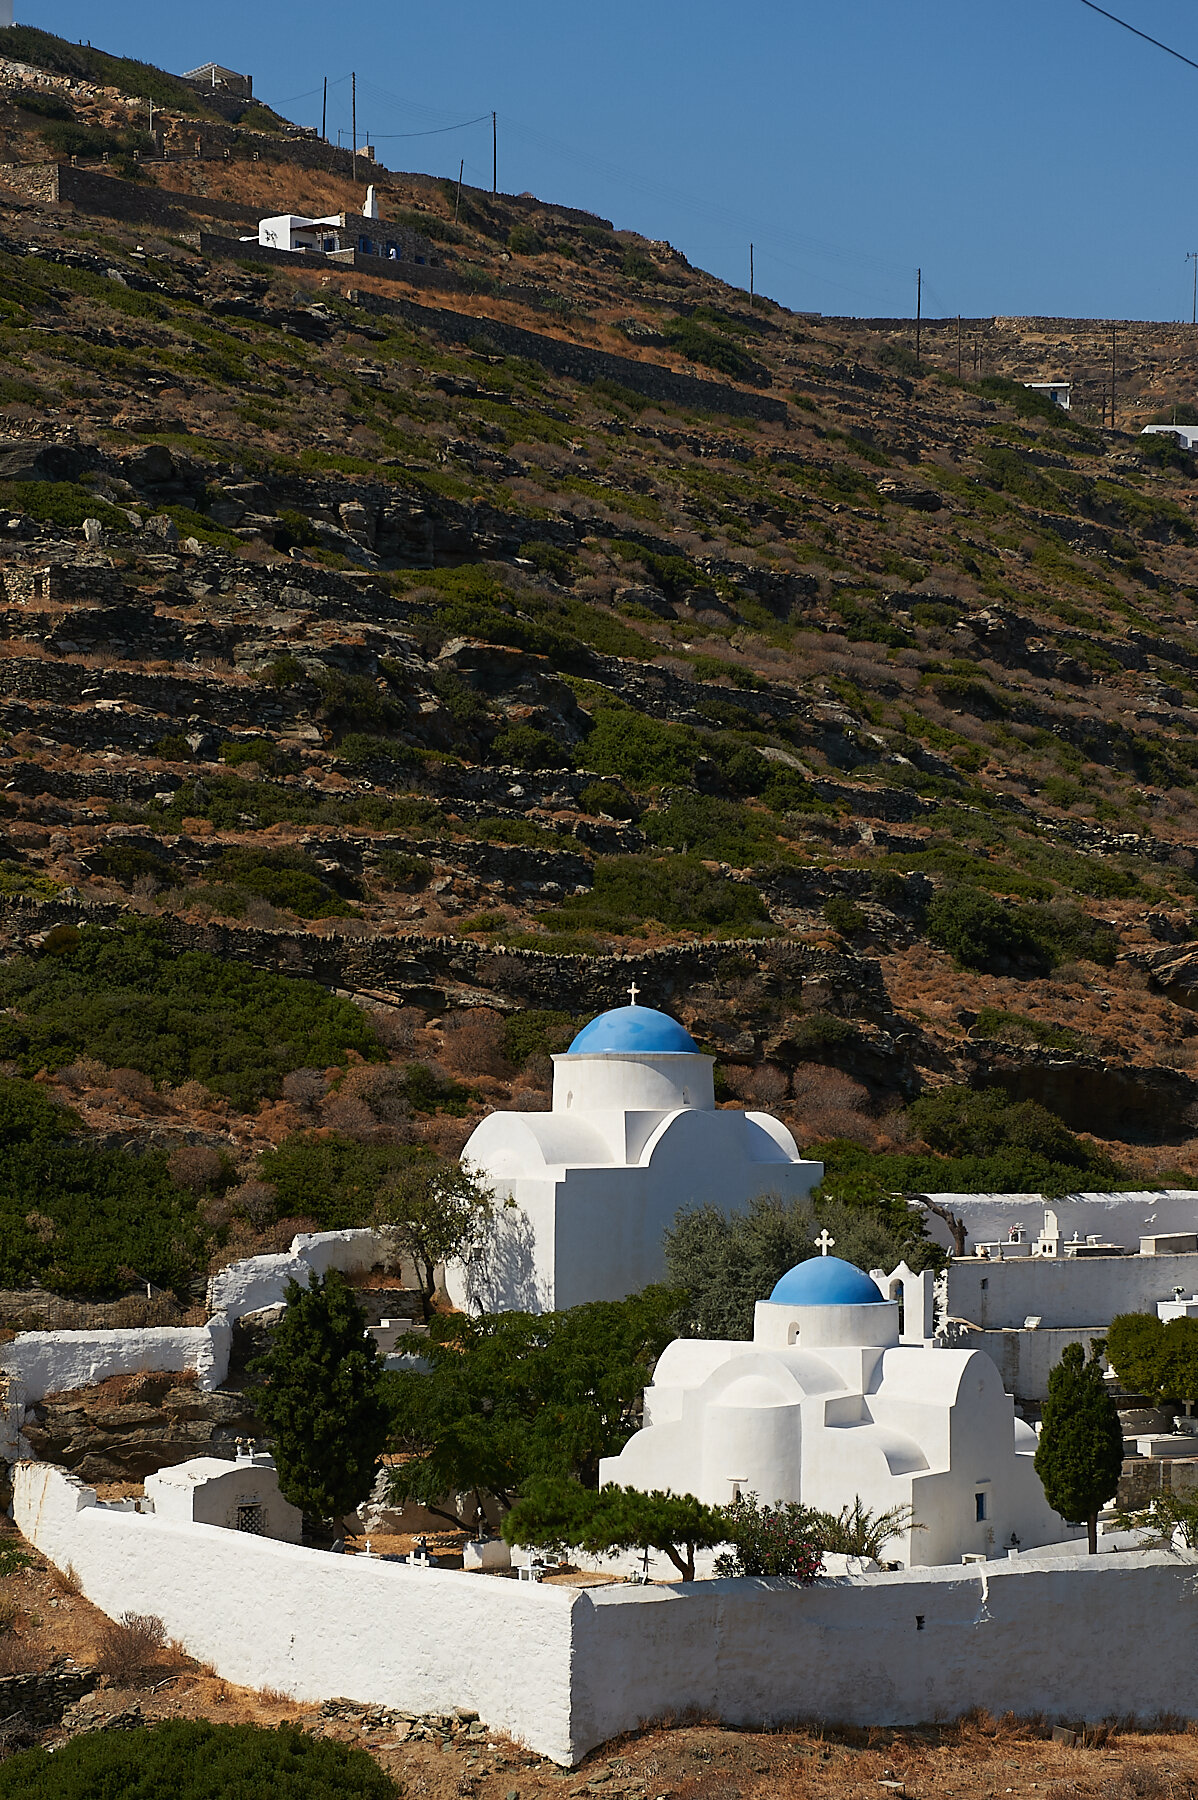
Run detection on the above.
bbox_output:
[545,857,770,932]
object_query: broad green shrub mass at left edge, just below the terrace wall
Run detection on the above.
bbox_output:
[0,920,383,1109]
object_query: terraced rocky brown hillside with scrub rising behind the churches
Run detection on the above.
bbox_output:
[0,29,1198,1292]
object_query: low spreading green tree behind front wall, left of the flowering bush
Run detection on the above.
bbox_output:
[504,1480,729,1580]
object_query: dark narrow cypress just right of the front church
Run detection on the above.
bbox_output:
[1036,1339,1122,1555]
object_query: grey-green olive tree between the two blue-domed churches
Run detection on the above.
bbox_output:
[666,1193,941,1337]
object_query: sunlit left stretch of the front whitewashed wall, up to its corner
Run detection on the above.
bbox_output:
[14,1463,576,1762]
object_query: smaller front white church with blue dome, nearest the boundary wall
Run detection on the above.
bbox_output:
[599,1240,1077,1566]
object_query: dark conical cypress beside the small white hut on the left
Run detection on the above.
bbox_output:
[252,1269,387,1519]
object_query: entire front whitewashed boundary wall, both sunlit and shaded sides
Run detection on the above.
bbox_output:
[14,1463,1198,1764]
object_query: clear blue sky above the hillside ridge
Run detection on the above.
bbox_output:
[16,0,1198,319]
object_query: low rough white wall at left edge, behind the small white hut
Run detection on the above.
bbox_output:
[0,1312,232,1462]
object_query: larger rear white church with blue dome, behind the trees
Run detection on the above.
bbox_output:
[446,986,824,1312]
